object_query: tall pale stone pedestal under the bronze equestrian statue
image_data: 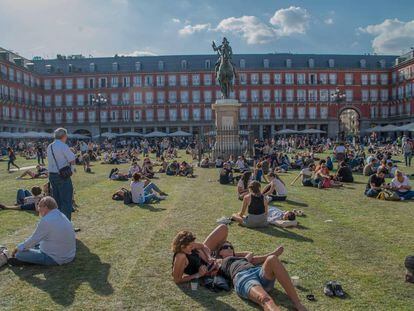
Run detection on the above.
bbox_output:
[212,99,243,160]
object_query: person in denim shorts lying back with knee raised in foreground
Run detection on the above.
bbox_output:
[215,242,307,311]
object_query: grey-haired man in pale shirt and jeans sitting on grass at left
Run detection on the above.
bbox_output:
[12,196,76,266]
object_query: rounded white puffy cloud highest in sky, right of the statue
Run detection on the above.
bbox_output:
[269,6,310,36]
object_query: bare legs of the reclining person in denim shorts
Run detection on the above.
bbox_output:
[249,255,306,311]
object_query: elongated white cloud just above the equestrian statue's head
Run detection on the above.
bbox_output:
[216,16,276,44]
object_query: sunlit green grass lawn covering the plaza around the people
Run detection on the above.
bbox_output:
[0,153,414,310]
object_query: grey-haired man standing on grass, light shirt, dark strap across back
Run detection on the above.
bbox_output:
[47,128,76,221]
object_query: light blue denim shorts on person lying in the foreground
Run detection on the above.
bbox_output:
[234,267,275,299]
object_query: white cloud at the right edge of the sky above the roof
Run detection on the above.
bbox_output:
[358,18,414,54]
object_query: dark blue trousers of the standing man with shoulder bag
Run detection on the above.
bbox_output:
[49,173,73,220]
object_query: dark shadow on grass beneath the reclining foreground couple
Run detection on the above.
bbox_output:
[178,284,237,311]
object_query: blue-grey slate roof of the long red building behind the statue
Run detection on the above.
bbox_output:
[32,53,398,75]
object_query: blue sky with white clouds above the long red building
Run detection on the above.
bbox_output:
[0,0,414,58]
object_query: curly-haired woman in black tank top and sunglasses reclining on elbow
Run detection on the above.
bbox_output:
[171,225,228,284]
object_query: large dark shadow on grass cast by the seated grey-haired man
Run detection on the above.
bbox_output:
[10,240,114,307]
